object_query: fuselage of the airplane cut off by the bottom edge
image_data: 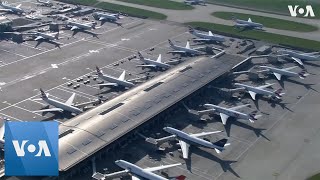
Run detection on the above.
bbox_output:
[115,160,168,180]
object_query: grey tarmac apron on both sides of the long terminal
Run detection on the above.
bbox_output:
[0,0,320,180]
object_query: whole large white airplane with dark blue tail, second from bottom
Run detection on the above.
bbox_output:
[146,127,229,159]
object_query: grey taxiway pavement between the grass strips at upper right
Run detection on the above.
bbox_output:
[100,0,320,41]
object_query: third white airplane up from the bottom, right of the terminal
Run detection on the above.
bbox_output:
[198,104,261,125]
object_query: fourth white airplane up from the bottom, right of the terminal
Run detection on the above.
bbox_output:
[234,83,285,100]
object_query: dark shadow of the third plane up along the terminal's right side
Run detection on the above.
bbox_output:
[224,117,270,141]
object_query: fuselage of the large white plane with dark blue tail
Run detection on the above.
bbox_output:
[164,127,223,150]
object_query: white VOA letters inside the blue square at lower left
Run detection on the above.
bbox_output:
[12,140,51,157]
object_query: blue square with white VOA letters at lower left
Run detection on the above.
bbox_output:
[4,121,59,176]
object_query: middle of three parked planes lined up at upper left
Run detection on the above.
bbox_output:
[66,21,99,36]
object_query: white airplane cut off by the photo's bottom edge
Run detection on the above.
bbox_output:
[92,160,185,180]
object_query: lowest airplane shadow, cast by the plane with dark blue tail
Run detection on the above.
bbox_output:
[185,146,241,178]
